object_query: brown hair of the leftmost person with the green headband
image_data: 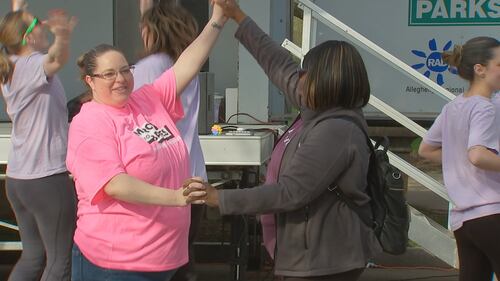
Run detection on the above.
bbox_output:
[0,11,28,84]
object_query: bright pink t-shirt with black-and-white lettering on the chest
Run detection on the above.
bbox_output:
[66,70,190,271]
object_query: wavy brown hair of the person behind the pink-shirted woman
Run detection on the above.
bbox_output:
[141,1,198,61]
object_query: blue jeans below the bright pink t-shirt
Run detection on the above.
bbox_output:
[71,244,177,281]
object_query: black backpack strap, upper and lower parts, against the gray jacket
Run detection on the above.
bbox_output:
[328,115,375,227]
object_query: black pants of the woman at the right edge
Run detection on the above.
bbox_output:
[454,214,500,281]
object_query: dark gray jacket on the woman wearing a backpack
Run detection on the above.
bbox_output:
[219,18,380,277]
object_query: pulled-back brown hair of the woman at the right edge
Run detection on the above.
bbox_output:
[442,36,500,82]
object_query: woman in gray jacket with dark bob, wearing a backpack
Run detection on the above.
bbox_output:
[191,0,379,280]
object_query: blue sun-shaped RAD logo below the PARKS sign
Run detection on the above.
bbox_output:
[411,39,457,86]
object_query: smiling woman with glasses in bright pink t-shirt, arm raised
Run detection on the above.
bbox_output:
[66,3,226,281]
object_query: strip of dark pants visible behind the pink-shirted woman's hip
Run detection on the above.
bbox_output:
[171,205,206,281]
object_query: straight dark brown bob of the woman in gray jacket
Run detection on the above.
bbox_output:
[303,40,370,111]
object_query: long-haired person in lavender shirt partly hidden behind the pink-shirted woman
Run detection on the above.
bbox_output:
[134,0,207,281]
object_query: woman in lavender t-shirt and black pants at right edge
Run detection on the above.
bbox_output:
[419,37,500,281]
